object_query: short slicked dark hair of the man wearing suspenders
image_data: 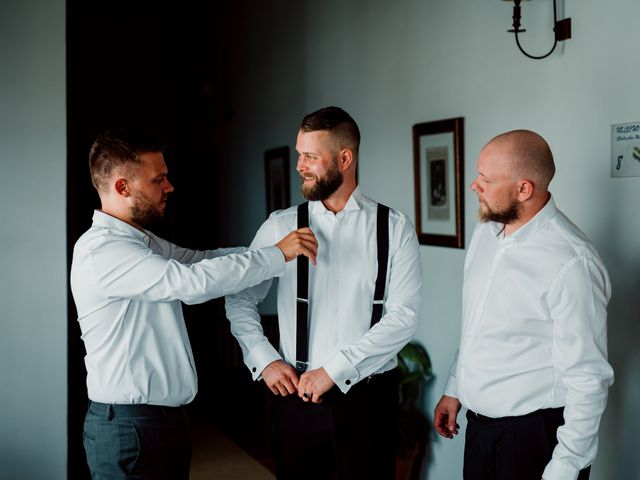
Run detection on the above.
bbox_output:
[300,107,360,156]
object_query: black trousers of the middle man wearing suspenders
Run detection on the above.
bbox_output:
[274,370,398,480]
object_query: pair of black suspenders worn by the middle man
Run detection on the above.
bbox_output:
[295,202,389,375]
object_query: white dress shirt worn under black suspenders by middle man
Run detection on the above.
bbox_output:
[226,188,422,392]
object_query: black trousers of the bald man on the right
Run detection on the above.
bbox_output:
[464,408,591,480]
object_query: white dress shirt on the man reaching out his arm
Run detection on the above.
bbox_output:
[71,211,284,406]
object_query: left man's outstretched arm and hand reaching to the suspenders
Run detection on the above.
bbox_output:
[87,228,315,304]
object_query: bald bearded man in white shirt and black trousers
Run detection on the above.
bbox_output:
[434,130,613,480]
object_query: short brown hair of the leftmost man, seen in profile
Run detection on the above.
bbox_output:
[89,129,165,192]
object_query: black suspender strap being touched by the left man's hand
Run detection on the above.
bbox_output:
[296,202,309,375]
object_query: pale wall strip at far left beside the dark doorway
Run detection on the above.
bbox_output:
[0,0,67,480]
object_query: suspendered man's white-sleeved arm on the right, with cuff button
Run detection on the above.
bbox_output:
[322,217,422,393]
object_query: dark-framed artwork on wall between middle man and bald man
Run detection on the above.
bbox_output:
[413,117,464,248]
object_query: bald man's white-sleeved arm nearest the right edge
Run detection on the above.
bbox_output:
[543,257,613,480]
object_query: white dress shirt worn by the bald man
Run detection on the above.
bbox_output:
[445,198,613,480]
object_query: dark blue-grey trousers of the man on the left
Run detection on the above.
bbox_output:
[83,402,191,480]
